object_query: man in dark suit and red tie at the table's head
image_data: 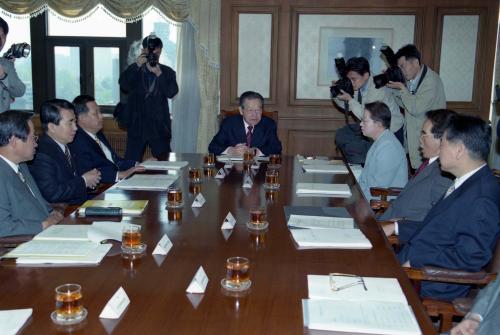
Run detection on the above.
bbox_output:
[208,91,281,156]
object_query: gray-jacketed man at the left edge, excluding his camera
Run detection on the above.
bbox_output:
[0,17,26,113]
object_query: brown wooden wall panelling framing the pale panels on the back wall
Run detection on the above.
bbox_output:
[220,0,499,155]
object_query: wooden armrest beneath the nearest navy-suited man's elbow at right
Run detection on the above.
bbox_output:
[404,266,497,285]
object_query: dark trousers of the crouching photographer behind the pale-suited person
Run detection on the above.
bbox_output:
[335,123,404,164]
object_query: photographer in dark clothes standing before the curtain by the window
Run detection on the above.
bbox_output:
[119,34,179,162]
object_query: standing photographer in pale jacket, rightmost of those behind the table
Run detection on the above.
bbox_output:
[386,44,446,169]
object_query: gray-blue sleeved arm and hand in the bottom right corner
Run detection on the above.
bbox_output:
[451,278,500,335]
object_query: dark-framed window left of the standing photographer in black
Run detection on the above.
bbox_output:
[47,6,126,112]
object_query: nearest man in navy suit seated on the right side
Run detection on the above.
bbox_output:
[384,115,500,300]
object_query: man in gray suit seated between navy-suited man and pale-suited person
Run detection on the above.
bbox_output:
[379,109,456,221]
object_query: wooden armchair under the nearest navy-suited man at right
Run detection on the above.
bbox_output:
[381,226,500,333]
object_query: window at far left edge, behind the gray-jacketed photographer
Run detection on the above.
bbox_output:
[2,16,33,110]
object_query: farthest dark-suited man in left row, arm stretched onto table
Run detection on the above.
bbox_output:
[69,95,144,183]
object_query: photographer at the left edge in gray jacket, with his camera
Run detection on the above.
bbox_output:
[0,17,26,113]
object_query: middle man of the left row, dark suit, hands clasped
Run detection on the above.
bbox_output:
[30,99,101,204]
